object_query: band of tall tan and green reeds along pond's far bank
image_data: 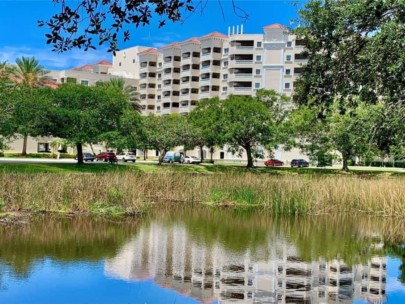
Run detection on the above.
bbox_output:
[0,172,405,216]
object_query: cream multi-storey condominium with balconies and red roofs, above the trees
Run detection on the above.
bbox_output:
[114,24,307,115]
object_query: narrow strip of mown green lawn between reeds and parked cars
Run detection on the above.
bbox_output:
[0,163,405,176]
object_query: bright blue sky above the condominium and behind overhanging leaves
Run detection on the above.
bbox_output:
[0,0,304,70]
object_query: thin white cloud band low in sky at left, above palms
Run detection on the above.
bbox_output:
[0,46,112,70]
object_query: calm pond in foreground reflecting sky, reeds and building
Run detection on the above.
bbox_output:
[0,207,405,304]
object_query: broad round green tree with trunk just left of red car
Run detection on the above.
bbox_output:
[47,84,133,163]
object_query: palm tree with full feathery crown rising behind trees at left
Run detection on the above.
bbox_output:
[11,56,49,155]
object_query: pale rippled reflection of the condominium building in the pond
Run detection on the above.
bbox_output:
[105,223,386,303]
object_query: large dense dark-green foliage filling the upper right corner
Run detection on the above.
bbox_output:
[294,0,405,108]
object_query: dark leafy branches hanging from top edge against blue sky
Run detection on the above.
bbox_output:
[39,0,194,52]
